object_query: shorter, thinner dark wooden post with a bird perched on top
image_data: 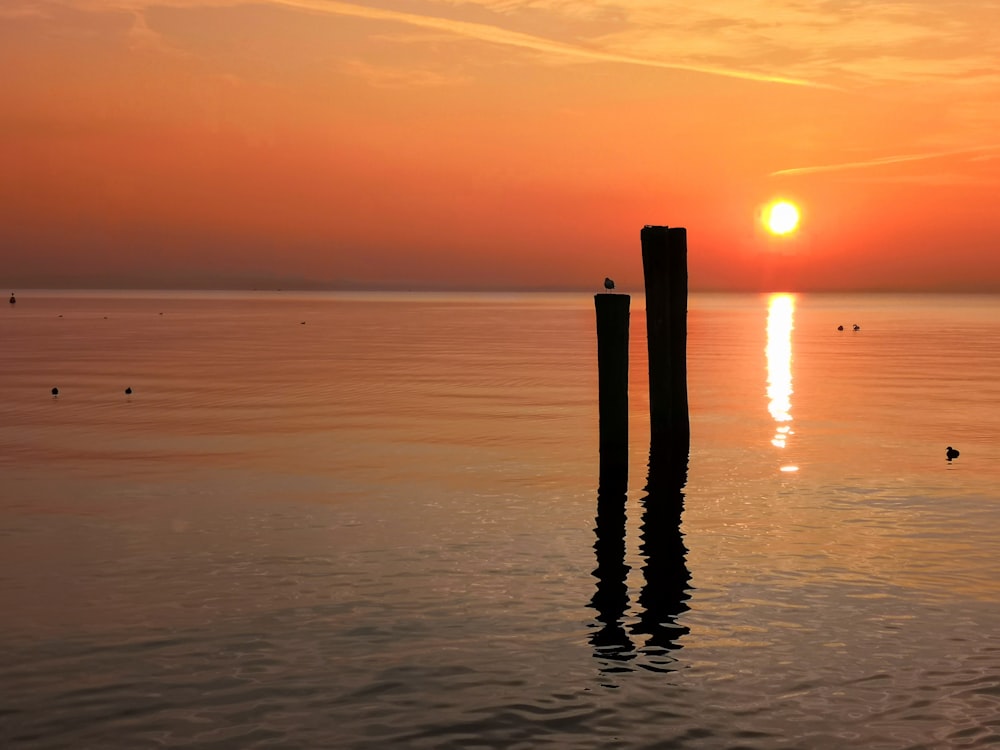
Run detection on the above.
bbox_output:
[594,293,631,488]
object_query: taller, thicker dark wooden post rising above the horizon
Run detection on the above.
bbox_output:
[640,226,691,464]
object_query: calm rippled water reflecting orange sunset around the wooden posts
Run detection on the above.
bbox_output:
[0,291,1000,750]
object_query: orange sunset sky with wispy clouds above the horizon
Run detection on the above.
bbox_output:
[0,0,1000,291]
